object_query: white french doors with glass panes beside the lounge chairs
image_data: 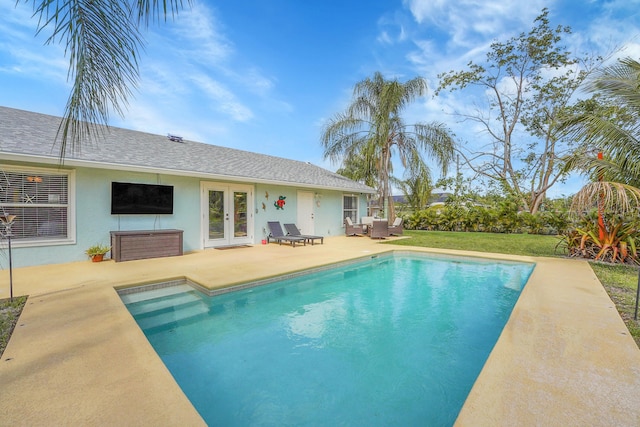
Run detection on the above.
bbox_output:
[201,182,253,248]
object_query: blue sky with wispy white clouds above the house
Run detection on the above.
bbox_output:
[0,0,640,196]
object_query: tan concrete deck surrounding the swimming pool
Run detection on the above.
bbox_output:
[0,236,640,426]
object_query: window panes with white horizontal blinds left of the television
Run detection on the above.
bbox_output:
[0,168,70,242]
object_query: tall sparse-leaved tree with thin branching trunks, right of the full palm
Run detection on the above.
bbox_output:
[436,8,599,213]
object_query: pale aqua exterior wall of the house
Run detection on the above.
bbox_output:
[0,163,366,269]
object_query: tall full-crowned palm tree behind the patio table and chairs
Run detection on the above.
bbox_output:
[321,72,455,221]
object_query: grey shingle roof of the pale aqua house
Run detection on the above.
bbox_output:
[0,106,374,193]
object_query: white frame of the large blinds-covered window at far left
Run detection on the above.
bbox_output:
[0,165,76,247]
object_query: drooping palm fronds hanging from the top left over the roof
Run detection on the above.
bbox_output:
[19,0,191,160]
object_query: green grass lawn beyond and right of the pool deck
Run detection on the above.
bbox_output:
[388,230,640,347]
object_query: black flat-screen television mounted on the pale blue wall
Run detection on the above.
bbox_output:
[111,182,173,215]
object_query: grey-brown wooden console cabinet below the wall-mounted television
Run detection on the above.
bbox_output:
[111,230,183,262]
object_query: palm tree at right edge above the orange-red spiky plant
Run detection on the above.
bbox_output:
[568,58,640,262]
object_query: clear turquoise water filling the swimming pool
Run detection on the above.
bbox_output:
[122,254,534,426]
